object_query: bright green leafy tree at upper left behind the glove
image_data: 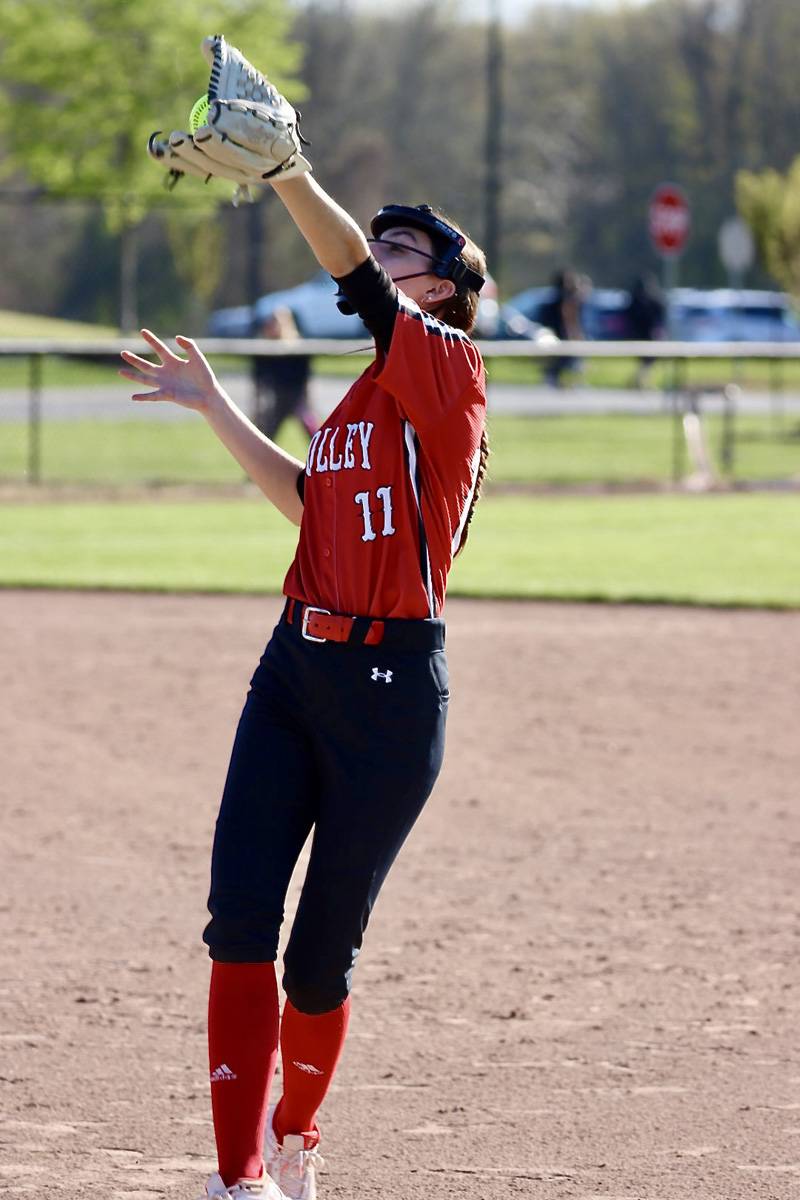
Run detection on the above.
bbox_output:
[0,0,300,329]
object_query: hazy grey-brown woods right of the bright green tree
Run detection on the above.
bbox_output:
[291,0,800,295]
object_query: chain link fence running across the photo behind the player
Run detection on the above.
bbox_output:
[0,340,800,494]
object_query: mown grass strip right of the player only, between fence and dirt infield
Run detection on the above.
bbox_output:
[452,494,800,607]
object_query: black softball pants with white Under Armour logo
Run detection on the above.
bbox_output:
[204,605,449,1013]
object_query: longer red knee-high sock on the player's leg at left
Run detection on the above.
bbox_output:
[209,962,279,1187]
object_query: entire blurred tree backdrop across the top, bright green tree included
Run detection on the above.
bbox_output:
[7,0,800,328]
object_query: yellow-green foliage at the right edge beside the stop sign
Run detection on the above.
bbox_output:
[736,157,800,298]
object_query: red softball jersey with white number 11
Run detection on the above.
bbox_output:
[283,294,486,618]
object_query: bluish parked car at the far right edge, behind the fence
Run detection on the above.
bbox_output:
[669,288,800,342]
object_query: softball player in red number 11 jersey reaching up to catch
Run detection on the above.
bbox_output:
[121,174,487,1200]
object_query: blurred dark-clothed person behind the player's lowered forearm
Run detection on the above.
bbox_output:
[253,308,319,438]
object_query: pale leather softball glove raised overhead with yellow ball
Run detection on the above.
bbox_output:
[148,35,311,203]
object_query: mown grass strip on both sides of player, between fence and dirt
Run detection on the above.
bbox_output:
[0,494,800,608]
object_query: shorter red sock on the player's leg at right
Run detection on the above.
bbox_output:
[272,996,350,1150]
